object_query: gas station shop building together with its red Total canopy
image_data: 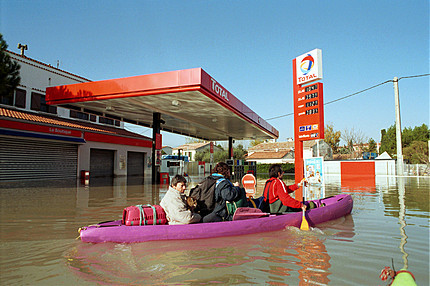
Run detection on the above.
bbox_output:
[0,51,279,181]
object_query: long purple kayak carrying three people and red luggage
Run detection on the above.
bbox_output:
[80,194,353,243]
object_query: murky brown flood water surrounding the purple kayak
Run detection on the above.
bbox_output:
[0,174,430,285]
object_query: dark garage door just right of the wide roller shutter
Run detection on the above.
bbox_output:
[90,148,115,178]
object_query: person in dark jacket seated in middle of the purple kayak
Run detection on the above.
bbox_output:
[203,162,246,222]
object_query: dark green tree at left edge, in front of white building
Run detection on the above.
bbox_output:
[0,34,21,101]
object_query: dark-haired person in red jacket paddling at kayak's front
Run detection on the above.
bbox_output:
[263,164,306,213]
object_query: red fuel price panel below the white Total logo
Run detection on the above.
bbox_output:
[294,82,324,141]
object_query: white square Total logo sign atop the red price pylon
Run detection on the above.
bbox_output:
[296,49,322,85]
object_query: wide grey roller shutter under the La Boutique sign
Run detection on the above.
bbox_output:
[0,137,78,181]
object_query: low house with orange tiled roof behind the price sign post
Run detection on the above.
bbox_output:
[246,140,333,164]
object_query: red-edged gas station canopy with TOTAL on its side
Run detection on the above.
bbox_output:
[46,68,279,141]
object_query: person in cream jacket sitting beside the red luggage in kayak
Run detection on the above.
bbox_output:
[160,175,202,224]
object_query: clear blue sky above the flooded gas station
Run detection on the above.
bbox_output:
[0,0,430,147]
